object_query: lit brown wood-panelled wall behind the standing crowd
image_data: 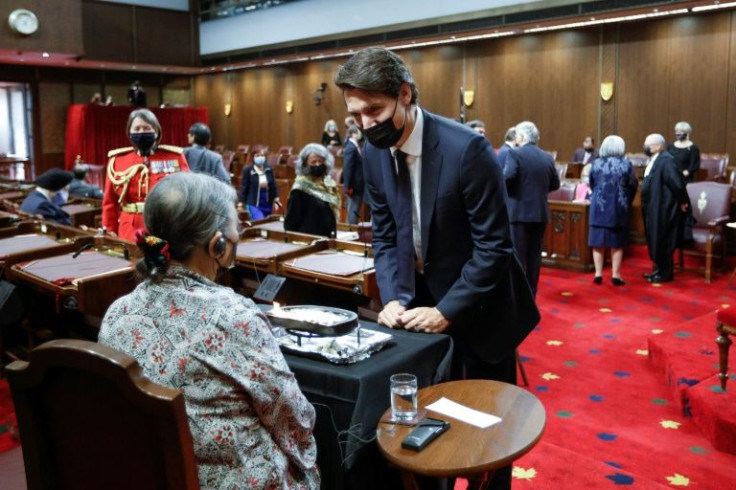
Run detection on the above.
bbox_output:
[194,12,736,161]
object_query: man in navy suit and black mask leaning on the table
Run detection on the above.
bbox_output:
[335,48,539,488]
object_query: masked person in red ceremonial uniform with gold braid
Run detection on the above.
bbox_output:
[102,109,189,241]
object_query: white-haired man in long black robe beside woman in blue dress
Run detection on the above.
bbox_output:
[641,134,689,283]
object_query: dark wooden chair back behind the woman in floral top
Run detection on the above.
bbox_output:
[6,339,199,490]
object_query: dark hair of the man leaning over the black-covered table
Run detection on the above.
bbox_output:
[334,47,419,104]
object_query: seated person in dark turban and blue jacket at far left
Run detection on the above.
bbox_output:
[20,168,73,225]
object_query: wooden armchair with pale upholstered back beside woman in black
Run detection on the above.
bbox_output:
[680,182,731,284]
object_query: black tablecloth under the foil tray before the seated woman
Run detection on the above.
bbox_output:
[285,321,452,490]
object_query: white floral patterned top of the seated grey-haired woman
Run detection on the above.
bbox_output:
[99,267,320,489]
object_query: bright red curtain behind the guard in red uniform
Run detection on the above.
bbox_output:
[65,104,209,169]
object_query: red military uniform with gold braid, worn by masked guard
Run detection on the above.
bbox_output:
[102,145,189,241]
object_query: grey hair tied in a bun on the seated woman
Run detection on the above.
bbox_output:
[136,172,238,281]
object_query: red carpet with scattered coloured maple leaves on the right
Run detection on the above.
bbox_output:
[504,251,736,490]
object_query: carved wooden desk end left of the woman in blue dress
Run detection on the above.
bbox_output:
[542,200,593,271]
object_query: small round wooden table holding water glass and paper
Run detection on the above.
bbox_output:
[377,380,546,488]
